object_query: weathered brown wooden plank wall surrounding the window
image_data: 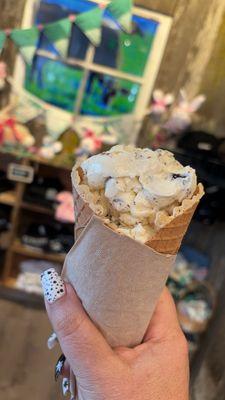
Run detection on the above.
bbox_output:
[0,0,225,130]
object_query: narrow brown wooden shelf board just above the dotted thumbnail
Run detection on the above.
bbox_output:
[12,239,65,264]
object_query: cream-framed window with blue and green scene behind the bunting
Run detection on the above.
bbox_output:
[16,0,171,118]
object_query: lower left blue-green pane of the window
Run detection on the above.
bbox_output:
[25,57,83,111]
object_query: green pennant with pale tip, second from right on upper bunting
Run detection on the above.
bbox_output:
[75,7,104,46]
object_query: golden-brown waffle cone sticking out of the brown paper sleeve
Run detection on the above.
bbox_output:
[72,168,204,254]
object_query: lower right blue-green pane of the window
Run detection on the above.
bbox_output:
[81,73,140,116]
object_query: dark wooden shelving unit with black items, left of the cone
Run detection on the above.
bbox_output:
[0,153,73,288]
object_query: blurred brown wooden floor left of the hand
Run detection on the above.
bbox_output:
[0,300,62,400]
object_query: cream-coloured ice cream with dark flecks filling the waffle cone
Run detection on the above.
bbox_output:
[80,145,197,243]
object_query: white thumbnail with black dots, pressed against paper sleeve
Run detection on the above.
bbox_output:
[41,268,66,304]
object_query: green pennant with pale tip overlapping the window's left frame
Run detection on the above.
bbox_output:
[10,27,39,65]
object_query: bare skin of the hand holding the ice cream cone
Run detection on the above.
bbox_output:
[46,284,189,400]
